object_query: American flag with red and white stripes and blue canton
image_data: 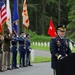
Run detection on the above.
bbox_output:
[0,0,7,25]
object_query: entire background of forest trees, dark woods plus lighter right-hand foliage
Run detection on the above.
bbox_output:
[10,0,75,37]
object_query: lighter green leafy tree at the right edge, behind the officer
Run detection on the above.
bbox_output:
[67,0,75,37]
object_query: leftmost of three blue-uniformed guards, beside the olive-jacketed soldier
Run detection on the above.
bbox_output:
[11,37,18,68]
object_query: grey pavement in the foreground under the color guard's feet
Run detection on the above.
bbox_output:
[0,63,53,75]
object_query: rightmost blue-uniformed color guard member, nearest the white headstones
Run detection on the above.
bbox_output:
[26,34,32,66]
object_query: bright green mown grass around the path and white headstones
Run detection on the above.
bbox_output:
[13,46,75,63]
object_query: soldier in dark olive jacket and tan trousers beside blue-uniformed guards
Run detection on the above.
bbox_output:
[3,29,11,70]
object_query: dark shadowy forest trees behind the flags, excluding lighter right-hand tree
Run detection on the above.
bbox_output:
[10,0,68,35]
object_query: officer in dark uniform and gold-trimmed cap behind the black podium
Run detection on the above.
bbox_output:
[50,24,71,75]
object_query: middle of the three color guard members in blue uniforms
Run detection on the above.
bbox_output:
[18,32,26,67]
